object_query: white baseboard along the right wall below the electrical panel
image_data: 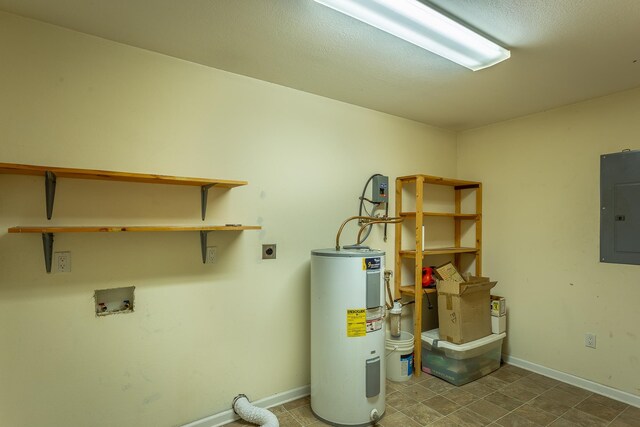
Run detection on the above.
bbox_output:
[502,354,640,408]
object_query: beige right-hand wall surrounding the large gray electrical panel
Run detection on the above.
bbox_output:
[458,89,640,396]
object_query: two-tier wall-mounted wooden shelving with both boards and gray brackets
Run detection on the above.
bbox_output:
[0,163,262,273]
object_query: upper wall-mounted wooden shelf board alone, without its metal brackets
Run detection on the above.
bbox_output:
[0,163,248,188]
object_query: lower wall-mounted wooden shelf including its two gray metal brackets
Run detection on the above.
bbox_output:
[7,224,262,273]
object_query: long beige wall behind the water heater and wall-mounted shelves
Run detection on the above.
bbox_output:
[0,13,460,427]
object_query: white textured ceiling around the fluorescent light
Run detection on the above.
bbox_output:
[0,0,640,130]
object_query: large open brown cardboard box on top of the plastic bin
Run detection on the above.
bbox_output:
[437,277,497,344]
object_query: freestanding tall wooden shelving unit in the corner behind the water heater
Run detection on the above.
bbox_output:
[394,175,482,376]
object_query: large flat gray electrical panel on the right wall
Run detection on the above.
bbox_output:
[600,151,640,264]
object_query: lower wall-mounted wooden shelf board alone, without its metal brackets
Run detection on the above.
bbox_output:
[8,225,262,233]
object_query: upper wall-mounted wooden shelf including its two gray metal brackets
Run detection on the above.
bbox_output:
[0,163,248,221]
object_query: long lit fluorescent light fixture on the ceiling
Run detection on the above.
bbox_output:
[315,0,511,71]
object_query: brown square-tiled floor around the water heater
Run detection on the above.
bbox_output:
[227,365,640,427]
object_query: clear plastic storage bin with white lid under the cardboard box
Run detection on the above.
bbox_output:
[421,329,507,385]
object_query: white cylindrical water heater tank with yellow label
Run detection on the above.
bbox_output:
[311,248,386,426]
